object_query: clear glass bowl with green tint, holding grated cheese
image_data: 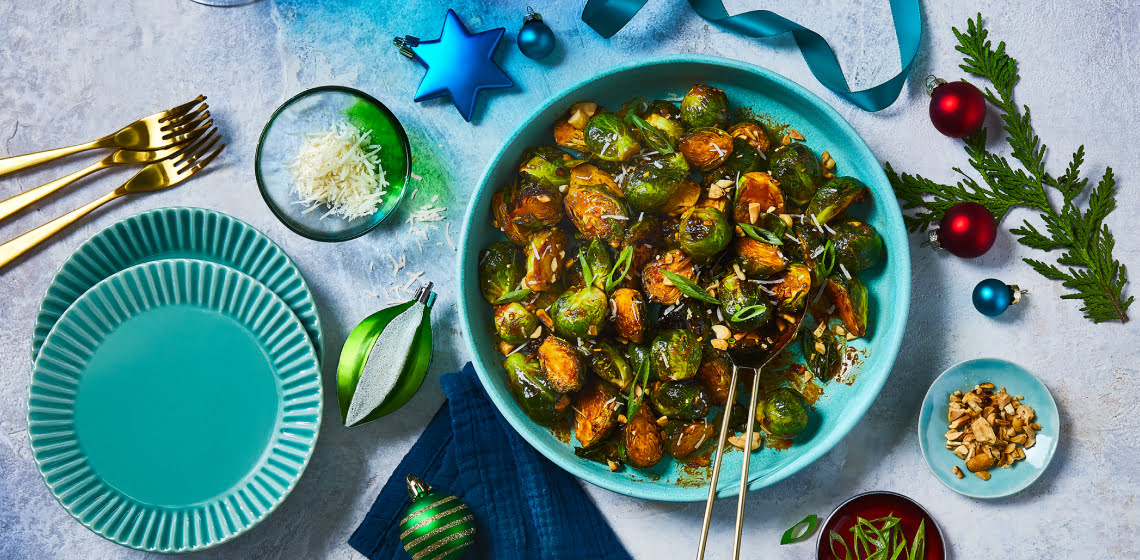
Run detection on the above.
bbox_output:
[254,86,412,242]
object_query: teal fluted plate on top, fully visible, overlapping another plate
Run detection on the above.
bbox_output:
[27,259,321,552]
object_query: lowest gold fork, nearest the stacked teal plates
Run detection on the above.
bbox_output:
[0,129,226,268]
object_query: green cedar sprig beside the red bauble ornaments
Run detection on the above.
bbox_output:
[886,14,1134,323]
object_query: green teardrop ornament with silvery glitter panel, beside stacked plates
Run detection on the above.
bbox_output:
[336,283,435,427]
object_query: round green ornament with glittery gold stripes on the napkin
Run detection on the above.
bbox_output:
[400,474,475,560]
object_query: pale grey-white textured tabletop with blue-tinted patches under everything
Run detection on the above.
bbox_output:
[0,0,1140,559]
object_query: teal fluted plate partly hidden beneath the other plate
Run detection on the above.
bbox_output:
[32,208,324,364]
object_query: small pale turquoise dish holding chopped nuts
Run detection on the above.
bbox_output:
[919,358,1060,498]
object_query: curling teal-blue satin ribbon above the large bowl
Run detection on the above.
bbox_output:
[581,0,922,111]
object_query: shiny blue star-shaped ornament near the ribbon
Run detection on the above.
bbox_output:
[407,10,514,122]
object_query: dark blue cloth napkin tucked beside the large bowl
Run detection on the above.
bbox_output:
[349,363,630,560]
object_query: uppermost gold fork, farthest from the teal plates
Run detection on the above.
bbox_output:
[0,95,210,176]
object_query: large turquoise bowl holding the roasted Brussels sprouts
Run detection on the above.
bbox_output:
[459,55,911,502]
